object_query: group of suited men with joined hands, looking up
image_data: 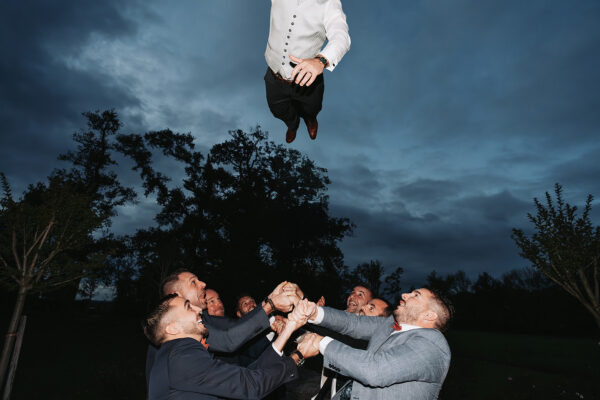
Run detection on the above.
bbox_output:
[144,271,453,400]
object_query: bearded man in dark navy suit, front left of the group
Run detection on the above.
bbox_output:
[144,294,306,400]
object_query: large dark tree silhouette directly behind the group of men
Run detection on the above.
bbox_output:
[119,127,352,308]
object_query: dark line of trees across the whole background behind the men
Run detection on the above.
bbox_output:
[0,111,600,368]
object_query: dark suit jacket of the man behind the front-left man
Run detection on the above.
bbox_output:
[146,307,270,386]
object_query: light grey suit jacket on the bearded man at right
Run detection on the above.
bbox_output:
[320,307,450,400]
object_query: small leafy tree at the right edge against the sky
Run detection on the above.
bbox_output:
[512,183,600,328]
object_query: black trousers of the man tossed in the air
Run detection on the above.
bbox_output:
[265,68,325,129]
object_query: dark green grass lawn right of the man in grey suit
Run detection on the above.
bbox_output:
[440,331,600,400]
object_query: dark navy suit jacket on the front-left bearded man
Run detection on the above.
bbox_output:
[148,338,298,400]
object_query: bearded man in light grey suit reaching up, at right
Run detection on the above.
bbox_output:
[298,288,453,400]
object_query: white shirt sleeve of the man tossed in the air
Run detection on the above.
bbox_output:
[321,0,350,71]
